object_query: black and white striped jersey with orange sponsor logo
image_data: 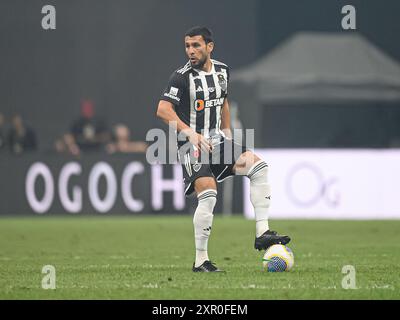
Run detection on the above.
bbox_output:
[161,59,229,138]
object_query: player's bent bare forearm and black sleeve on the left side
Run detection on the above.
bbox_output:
[157,72,211,152]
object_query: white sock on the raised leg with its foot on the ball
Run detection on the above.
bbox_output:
[247,160,271,237]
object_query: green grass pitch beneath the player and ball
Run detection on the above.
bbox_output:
[0,215,400,299]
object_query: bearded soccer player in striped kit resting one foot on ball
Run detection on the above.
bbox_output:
[157,27,290,272]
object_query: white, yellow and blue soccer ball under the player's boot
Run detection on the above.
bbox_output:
[262,244,294,272]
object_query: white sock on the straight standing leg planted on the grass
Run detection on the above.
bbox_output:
[193,189,217,267]
